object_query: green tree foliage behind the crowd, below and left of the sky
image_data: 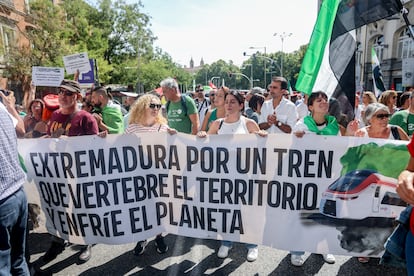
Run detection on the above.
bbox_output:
[5,0,306,99]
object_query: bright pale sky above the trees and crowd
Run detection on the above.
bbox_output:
[140,0,318,67]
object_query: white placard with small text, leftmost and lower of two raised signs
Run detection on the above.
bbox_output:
[32,66,64,87]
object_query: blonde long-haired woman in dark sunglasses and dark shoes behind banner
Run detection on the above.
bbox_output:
[125,94,177,255]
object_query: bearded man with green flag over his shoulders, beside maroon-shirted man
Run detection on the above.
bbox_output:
[91,87,124,134]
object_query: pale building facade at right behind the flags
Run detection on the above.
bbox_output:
[318,0,414,91]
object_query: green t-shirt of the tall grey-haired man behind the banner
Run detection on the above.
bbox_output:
[167,96,198,134]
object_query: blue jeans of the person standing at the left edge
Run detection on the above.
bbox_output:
[0,188,30,275]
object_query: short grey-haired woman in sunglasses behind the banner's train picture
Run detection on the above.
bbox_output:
[354,103,409,141]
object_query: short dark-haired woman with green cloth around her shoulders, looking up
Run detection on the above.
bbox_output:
[290,91,341,266]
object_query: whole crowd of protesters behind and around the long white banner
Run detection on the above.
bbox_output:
[0,77,414,275]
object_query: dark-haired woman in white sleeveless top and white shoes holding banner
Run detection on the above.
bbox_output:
[197,90,267,262]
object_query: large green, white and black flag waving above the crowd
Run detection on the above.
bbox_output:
[296,0,402,117]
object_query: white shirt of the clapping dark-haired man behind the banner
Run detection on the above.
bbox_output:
[259,97,298,133]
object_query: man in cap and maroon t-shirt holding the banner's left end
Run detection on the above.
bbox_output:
[43,79,99,262]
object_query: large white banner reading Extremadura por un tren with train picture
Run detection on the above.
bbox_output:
[19,133,409,256]
